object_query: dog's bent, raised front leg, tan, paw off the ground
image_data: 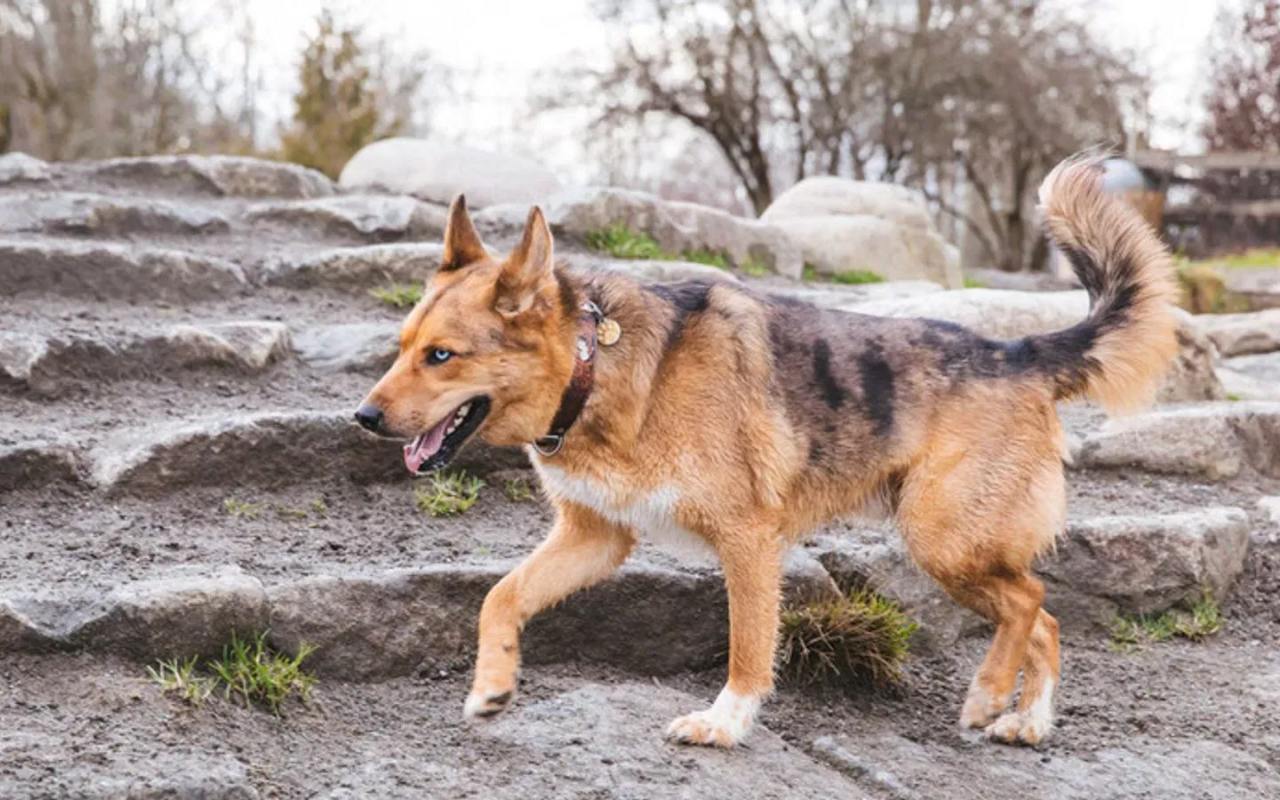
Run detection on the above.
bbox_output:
[463,503,635,717]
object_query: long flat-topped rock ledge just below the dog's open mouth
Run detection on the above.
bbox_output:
[90,410,526,495]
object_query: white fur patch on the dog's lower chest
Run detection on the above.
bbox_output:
[527,463,714,561]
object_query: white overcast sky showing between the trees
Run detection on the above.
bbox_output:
[241,0,1238,166]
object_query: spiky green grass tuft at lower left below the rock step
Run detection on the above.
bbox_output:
[147,632,316,717]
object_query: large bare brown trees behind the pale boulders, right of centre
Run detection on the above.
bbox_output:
[543,0,1142,269]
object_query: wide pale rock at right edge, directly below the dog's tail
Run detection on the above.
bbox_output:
[1074,402,1280,480]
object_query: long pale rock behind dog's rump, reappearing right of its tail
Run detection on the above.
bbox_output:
[844,289,1224,402]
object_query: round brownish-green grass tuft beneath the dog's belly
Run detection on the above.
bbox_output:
[780,589,918,686]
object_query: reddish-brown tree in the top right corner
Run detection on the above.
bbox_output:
[1204,0,1280,152]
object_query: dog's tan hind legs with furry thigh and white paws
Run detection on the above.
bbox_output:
[897,403,1065,744]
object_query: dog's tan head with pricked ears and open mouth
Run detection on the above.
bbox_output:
[356,196,579,474]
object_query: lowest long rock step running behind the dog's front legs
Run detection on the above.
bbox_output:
[0,553,837,681]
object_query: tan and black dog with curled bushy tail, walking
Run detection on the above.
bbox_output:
[356,157,1176,748]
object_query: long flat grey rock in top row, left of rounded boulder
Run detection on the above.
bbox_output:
[81,155,334,198]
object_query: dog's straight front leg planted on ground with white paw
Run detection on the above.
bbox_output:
[667,532,782,748]
